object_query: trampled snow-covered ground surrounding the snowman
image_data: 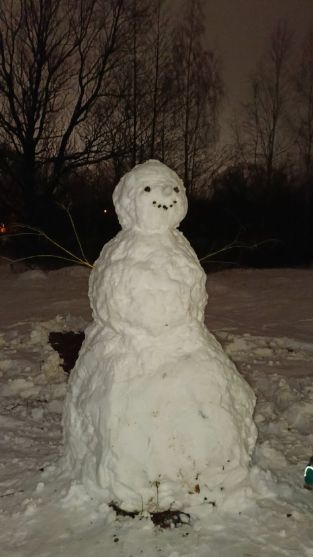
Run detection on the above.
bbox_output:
[0,265,313,557]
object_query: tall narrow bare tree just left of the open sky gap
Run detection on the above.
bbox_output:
[169,0,223,192]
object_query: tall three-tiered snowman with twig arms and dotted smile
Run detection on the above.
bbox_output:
[64,160,256,511]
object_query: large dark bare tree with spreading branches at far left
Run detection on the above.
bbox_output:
[0,0,123,218]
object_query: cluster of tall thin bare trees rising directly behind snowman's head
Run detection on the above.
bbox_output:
[89,0,223,190]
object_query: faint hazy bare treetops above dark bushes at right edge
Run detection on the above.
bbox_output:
[233,22,313,189]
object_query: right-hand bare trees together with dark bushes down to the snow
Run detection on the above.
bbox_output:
[210,21,313,265]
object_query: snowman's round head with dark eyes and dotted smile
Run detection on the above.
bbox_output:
[113,160,187,232]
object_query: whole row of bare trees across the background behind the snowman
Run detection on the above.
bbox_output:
[0,0,313,264]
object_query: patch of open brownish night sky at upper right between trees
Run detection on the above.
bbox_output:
[205,0,313,138]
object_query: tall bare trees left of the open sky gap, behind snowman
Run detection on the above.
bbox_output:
[0,0,223,219]
